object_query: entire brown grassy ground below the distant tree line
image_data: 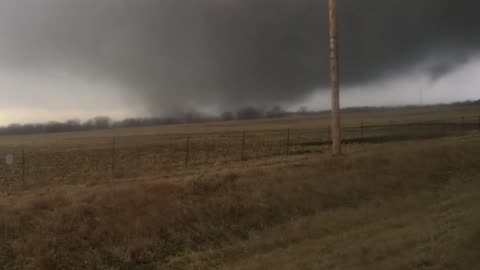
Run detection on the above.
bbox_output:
[0,106,480,270]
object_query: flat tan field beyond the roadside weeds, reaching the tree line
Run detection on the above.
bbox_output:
[0,103,478,190]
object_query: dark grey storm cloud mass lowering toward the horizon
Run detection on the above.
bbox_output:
[0,0,480,113]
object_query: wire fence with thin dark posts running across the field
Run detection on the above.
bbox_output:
[0,116,480,191]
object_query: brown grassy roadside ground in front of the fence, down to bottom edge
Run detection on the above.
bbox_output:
[0,132,480,269]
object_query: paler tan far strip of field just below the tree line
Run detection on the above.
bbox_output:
[0,106,480,147]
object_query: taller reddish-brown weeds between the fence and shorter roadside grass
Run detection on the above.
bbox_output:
[0,136,480,269]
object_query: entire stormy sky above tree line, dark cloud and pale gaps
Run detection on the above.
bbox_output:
[0,0,480,124]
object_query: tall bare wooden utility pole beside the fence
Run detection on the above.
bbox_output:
[329,0,342,155]
